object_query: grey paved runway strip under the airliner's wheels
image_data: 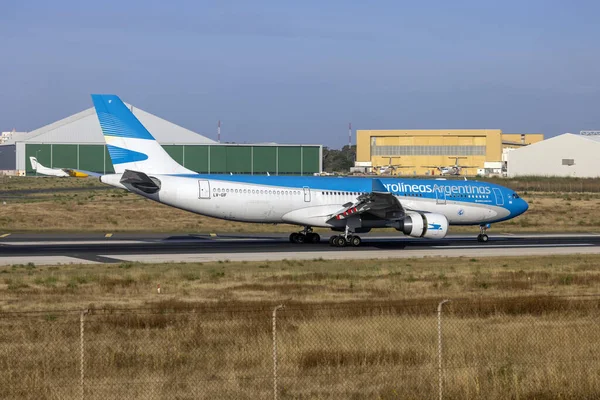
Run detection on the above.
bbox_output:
[0,233,600,265]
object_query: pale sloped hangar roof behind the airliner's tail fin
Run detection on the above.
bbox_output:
[8,103,216,144]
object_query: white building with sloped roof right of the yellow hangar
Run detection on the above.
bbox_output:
[508,133,600,178]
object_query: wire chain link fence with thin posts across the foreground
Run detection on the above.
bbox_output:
[0,297,600,399]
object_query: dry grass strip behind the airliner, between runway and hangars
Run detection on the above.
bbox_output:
[0,177,600,233]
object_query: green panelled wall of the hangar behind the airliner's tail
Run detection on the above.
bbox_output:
[25,143,322,175]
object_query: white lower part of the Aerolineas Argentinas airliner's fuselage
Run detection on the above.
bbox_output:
[113,175,509,227]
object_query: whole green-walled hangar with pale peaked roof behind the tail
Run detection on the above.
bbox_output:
[0,104,323,175]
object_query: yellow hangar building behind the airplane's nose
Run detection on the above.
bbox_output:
[356,129,544,175]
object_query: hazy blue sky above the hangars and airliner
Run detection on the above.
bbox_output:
[0,0,600,148]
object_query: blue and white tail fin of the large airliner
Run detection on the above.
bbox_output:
[92,94,194,174]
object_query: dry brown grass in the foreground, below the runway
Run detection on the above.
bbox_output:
[0,256,600,399]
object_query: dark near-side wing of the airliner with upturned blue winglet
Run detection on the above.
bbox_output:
[330,179,405,219]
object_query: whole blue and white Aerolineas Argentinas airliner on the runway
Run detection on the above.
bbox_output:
[92,95,528,246]
